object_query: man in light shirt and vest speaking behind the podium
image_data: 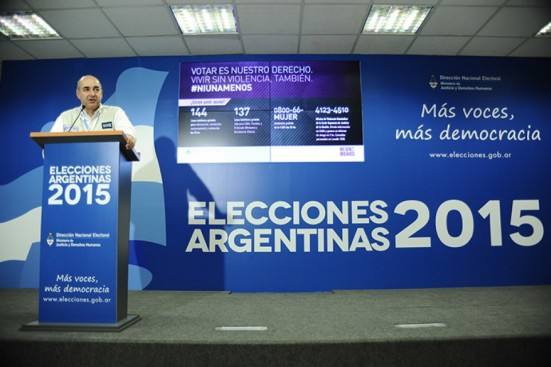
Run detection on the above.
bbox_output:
[50,75,136,149]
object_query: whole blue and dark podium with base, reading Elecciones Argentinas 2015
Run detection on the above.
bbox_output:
[21,131,140,331]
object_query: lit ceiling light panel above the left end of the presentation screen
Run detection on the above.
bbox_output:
[170,4,237,35]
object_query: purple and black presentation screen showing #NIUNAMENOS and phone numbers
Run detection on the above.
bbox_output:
[178,61,364,163]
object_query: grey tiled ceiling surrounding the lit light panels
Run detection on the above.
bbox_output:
[0,0,551,65]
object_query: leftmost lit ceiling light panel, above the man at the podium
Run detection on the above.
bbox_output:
[0,13,61,40]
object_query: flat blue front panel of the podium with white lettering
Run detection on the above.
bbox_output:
[38,142,119,323]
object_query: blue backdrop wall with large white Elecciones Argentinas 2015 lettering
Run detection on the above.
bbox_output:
[0,55,551,291]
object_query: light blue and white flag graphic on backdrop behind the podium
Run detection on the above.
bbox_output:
[0,67,168,289]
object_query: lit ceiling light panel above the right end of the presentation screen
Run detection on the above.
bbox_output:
[363,5,432,34]
